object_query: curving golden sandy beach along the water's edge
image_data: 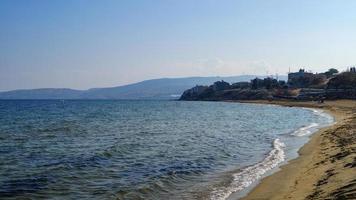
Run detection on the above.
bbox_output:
[236,100,356,200]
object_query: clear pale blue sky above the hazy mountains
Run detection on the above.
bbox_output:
[0,0,356,91]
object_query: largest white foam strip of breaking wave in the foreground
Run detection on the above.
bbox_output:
[210,139,285,200]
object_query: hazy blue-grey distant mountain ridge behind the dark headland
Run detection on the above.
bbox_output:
[0,75,286,99]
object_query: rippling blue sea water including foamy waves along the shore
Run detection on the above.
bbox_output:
[0,100,333,199]
